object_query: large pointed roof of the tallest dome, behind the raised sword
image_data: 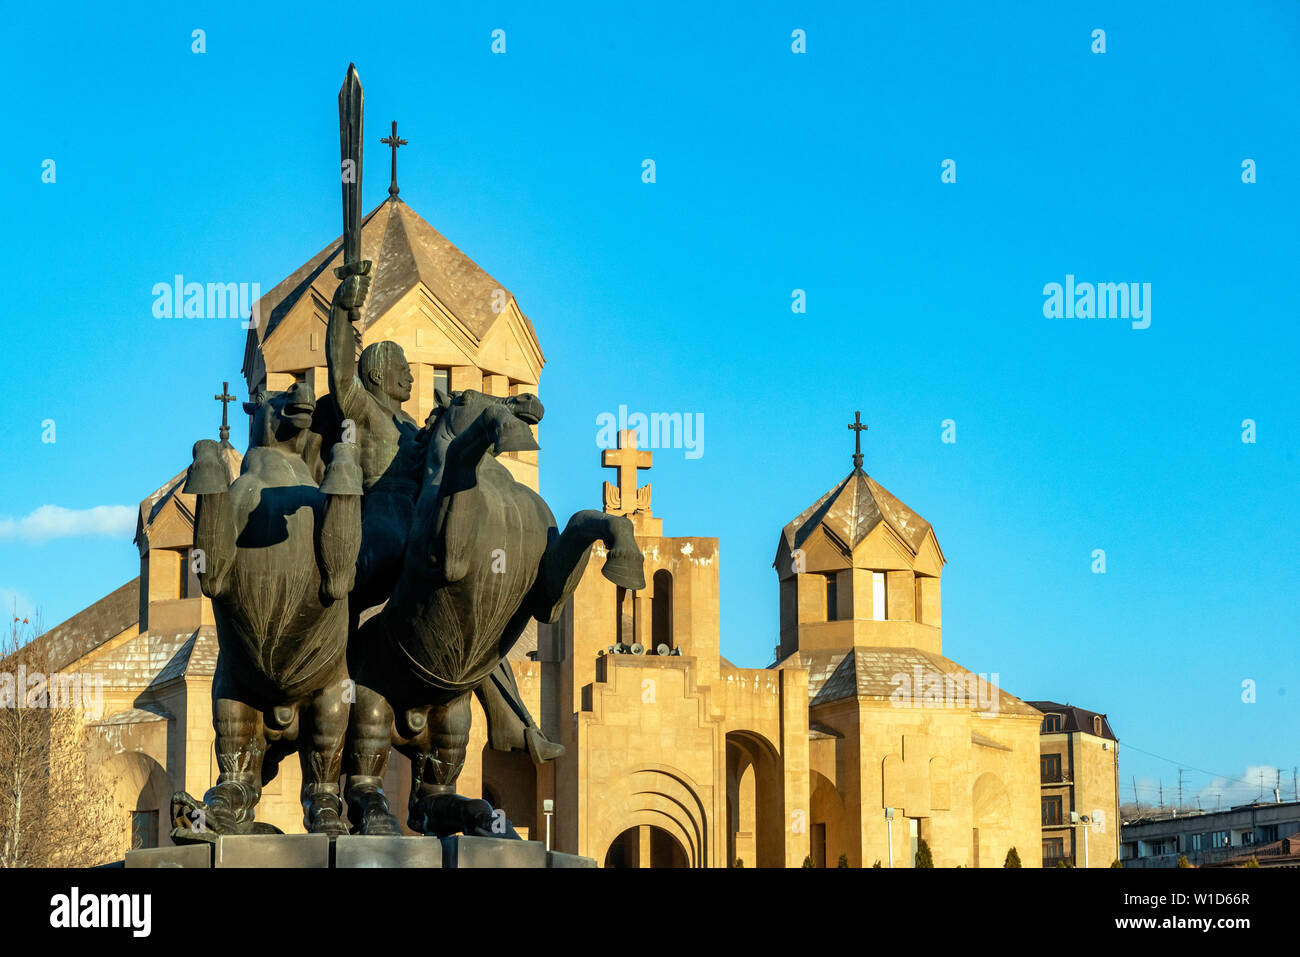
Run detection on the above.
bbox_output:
[243,198,537,376]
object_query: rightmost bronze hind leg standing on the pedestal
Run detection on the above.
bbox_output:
[407,692,493,837]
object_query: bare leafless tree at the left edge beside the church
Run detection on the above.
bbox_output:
[0,611,121,867]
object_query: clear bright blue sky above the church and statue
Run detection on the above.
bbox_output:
[0,3,1300,804]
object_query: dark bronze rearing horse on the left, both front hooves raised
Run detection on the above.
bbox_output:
[172,382,361,841]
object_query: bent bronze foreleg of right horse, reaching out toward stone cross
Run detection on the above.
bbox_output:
[533,508,646,623]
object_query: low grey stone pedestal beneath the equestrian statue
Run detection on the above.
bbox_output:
[125,833,595,869]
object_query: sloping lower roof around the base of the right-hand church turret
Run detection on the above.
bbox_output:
[783,648,1037,716]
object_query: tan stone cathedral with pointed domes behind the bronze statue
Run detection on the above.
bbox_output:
[39,195,1043,867]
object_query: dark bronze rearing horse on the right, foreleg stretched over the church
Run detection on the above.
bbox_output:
[347,390,645,836]
